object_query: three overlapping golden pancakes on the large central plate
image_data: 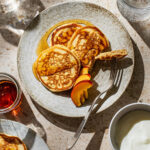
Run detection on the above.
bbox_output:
[34,23,127,92]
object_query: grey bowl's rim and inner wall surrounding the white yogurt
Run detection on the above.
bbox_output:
[109,103,150,150]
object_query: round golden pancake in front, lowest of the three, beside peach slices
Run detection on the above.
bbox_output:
[35,45,80,92]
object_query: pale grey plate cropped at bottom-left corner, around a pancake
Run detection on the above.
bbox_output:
[0,119,49,150]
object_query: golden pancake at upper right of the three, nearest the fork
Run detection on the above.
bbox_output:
[68,26,109,68]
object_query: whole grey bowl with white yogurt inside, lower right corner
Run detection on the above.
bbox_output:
[109,103,150,150]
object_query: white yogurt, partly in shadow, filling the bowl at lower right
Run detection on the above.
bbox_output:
[115,110,150,150]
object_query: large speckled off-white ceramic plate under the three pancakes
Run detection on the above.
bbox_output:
[18,2,134,117]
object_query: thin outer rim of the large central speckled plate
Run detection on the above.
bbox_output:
[17,1,135,118]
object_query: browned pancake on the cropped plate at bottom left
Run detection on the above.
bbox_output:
[0,133,27,150]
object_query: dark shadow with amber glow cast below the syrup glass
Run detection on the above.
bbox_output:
[0,95,47,145]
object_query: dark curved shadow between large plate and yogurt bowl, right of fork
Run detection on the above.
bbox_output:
[86,41,145,150]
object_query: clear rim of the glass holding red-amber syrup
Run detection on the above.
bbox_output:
[0,72,22,114]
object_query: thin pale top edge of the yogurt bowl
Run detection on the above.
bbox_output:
[108,102,150,150]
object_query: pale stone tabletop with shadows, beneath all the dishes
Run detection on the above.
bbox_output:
[0,0,150,150]
